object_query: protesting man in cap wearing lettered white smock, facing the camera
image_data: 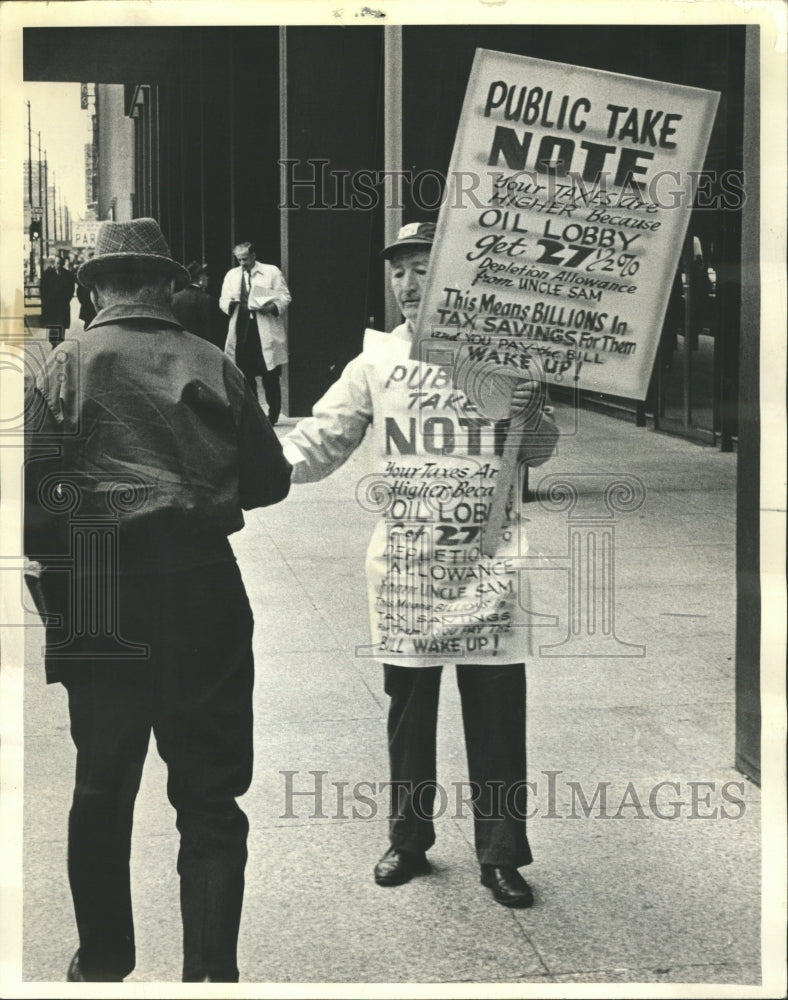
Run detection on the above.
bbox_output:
[283,223,557,907]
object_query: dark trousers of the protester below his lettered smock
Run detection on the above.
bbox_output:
[384,663,532,868]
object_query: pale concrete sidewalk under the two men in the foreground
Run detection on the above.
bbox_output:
[24,408,761,996]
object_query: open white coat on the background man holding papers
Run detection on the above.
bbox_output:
[219,260,291,369]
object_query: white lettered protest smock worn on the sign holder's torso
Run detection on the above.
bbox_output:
[358,330,534,667]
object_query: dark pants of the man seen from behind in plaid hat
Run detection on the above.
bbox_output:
[53,562,254,982]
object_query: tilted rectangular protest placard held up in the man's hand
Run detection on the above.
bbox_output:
[414,49,719,402]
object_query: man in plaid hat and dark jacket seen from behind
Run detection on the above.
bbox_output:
[25,219,291,982]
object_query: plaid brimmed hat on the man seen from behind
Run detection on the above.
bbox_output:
[77,219,189,288]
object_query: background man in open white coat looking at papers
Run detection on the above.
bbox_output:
[219,243,291,425]
